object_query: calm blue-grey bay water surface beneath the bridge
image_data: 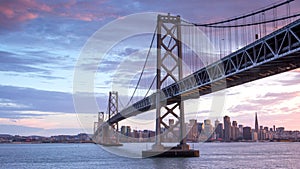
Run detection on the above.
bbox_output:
[0,143,300,169]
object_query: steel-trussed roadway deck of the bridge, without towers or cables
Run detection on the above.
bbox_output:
[106,19,300,124]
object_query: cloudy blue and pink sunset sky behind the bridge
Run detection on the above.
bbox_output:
[0,0,300,136]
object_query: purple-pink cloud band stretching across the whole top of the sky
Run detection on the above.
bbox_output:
[0,0,299,33]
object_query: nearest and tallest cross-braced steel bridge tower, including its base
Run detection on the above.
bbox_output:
[143,14,199,157]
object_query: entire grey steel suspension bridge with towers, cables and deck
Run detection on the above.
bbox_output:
[94,0,300,157]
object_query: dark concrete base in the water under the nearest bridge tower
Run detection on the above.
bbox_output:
[142,147,200,158]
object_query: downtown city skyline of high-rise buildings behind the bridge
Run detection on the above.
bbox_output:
[120,114,300,142]
